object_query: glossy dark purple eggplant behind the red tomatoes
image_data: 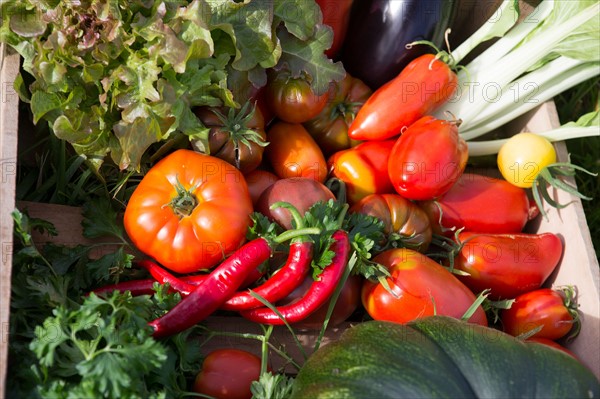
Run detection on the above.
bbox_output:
[341,0,458,90]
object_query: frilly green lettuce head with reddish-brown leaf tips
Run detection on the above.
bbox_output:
[0,0,345,172]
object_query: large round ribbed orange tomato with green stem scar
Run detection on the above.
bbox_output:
[124,150,253,273]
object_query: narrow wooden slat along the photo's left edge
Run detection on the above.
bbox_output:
[0,44,19,398]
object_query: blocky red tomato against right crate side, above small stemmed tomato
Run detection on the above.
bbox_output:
[454,232,563,299]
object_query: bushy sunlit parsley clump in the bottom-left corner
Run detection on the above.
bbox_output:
[30,292,167,398]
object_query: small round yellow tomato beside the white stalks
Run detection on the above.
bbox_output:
[498,133,556,188]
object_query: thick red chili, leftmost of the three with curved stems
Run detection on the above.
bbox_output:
[148,237,272,338]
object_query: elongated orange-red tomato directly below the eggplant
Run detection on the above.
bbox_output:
[348,54,458,140]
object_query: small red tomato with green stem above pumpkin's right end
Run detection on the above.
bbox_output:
[501,287,579,340]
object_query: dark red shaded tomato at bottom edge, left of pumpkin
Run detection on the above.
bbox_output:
[194,349,261,399]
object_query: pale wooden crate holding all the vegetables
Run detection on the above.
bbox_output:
[0,1,600,398]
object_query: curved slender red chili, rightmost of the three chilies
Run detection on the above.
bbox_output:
[240,230,350,325]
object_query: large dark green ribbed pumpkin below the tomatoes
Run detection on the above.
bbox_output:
[292,316,600,399]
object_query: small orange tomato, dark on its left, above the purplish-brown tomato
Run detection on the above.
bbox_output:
[265,121,327,183]
